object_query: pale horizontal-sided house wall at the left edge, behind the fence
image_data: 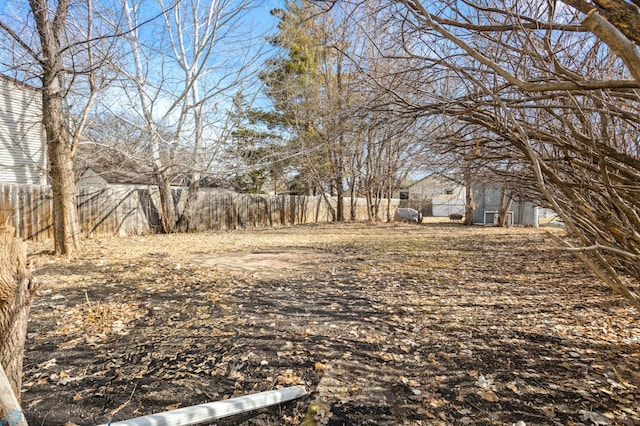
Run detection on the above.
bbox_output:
[0,74,47,185]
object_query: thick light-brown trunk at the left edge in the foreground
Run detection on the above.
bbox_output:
[0,227,36,399]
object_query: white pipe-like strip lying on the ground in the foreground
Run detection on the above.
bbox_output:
[101,386,307,426]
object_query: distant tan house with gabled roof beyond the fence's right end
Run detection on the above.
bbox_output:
[394,173,466,217]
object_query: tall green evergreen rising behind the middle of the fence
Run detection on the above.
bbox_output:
[260,1,348,220]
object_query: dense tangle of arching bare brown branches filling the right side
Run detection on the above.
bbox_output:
[358,0,640,306]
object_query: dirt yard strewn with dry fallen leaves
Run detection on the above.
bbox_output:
[22,223,640,426]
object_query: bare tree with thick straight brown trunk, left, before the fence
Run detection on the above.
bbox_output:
[0,0,113,256]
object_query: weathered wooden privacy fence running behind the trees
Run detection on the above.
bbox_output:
[0,185,398,241]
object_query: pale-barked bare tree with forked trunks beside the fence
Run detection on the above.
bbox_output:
[112,0,259,232]
